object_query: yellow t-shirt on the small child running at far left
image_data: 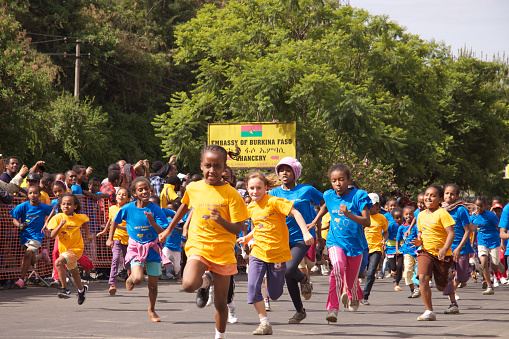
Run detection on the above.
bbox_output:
[48,213,88,258]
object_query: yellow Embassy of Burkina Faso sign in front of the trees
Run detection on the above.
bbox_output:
[208,122,296,168]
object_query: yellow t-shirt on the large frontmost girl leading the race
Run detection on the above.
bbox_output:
[182,180,249,265]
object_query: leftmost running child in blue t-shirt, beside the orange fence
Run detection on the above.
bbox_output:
[9,186,53,288]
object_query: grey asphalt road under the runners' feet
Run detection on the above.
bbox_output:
[0,275,509,339]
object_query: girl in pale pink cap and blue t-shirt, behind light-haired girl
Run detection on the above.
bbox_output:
[269,157,323,324]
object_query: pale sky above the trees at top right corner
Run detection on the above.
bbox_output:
[350,0,509,60]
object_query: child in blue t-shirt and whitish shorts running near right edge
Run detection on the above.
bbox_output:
[470,197,500,295]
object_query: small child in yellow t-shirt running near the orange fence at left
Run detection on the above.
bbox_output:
[48,193,94,305]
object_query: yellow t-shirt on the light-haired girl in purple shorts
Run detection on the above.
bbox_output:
[247,195,293,263]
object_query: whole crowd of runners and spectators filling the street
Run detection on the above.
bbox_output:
[0,149,509,338]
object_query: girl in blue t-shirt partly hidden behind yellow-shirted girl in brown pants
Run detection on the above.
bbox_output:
[442,184,474,314]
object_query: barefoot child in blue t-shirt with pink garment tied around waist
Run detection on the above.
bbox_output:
[106,177,168,323]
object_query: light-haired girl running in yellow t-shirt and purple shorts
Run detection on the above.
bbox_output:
[238,171,314,335]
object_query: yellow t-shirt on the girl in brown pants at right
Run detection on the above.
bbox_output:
[417,207,455,256]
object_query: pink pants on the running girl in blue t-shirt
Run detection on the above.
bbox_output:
[327,246,363,310]
